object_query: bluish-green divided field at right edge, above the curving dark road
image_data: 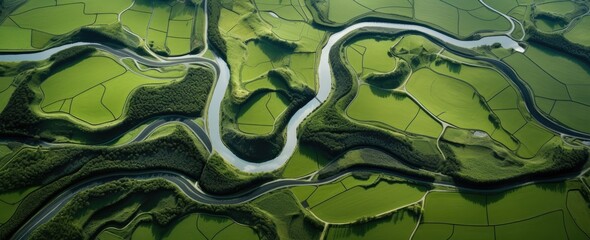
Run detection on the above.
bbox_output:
[504,45,590,132]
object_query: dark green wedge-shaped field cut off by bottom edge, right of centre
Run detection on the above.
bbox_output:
[326,210,417,239]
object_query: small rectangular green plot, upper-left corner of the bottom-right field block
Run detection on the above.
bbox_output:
[424,192,488,226]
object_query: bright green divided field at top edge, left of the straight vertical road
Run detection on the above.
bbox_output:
[121,0,204,56]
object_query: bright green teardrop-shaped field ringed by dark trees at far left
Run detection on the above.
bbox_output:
[40,56,176,125]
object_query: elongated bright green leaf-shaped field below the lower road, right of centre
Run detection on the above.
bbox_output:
[310,181,424,223]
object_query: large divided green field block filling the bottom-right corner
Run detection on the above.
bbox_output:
[414,181,588,239]
